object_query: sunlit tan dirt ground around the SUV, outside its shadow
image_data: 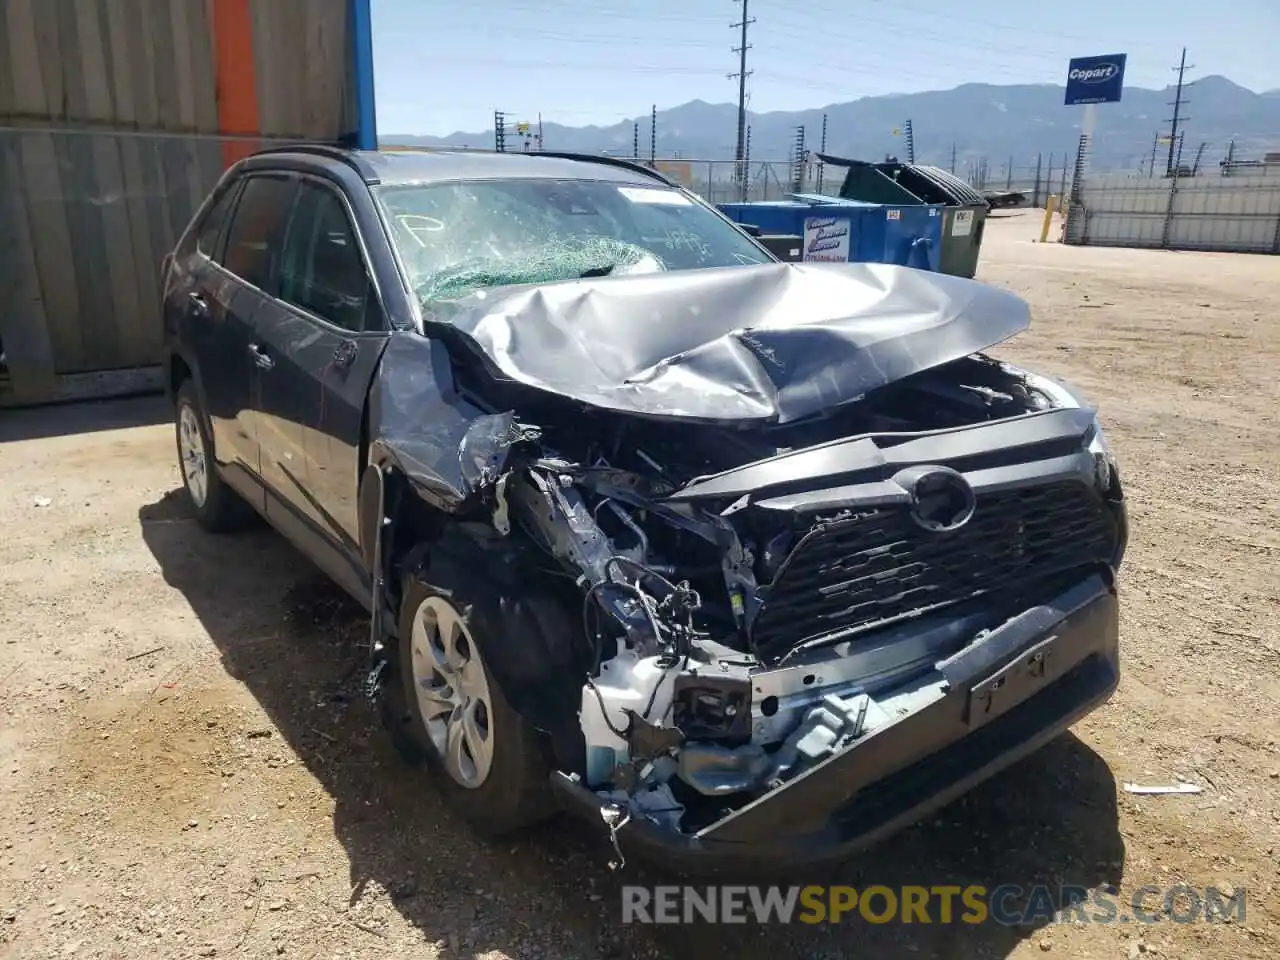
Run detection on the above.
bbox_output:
[0,214,1280,960]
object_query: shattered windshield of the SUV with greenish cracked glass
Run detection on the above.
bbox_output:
[376,179,768,302]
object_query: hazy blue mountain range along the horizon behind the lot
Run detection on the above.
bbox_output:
[380,76,1280,179]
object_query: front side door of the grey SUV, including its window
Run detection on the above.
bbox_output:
[255,177,387,596]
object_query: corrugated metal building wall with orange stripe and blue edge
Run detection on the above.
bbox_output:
[0,0,375,406]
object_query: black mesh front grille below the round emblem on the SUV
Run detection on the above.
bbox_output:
[751,481,1119,660]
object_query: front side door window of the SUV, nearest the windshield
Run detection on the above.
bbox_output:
[279,180,375,332]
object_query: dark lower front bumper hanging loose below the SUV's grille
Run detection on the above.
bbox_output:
[552,575,1120,876]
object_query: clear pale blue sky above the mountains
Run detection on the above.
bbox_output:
[372,0,1280,136]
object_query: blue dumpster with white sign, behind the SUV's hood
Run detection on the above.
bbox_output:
[718,193,943,271]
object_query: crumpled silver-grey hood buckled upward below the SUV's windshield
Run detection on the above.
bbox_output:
[426,264,1030,422]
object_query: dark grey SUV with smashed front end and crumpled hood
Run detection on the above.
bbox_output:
[164,146,1126,870]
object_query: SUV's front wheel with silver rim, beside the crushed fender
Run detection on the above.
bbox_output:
[388,563,554,837]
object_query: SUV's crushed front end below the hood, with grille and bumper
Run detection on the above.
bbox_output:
[495,356,1126,872]
